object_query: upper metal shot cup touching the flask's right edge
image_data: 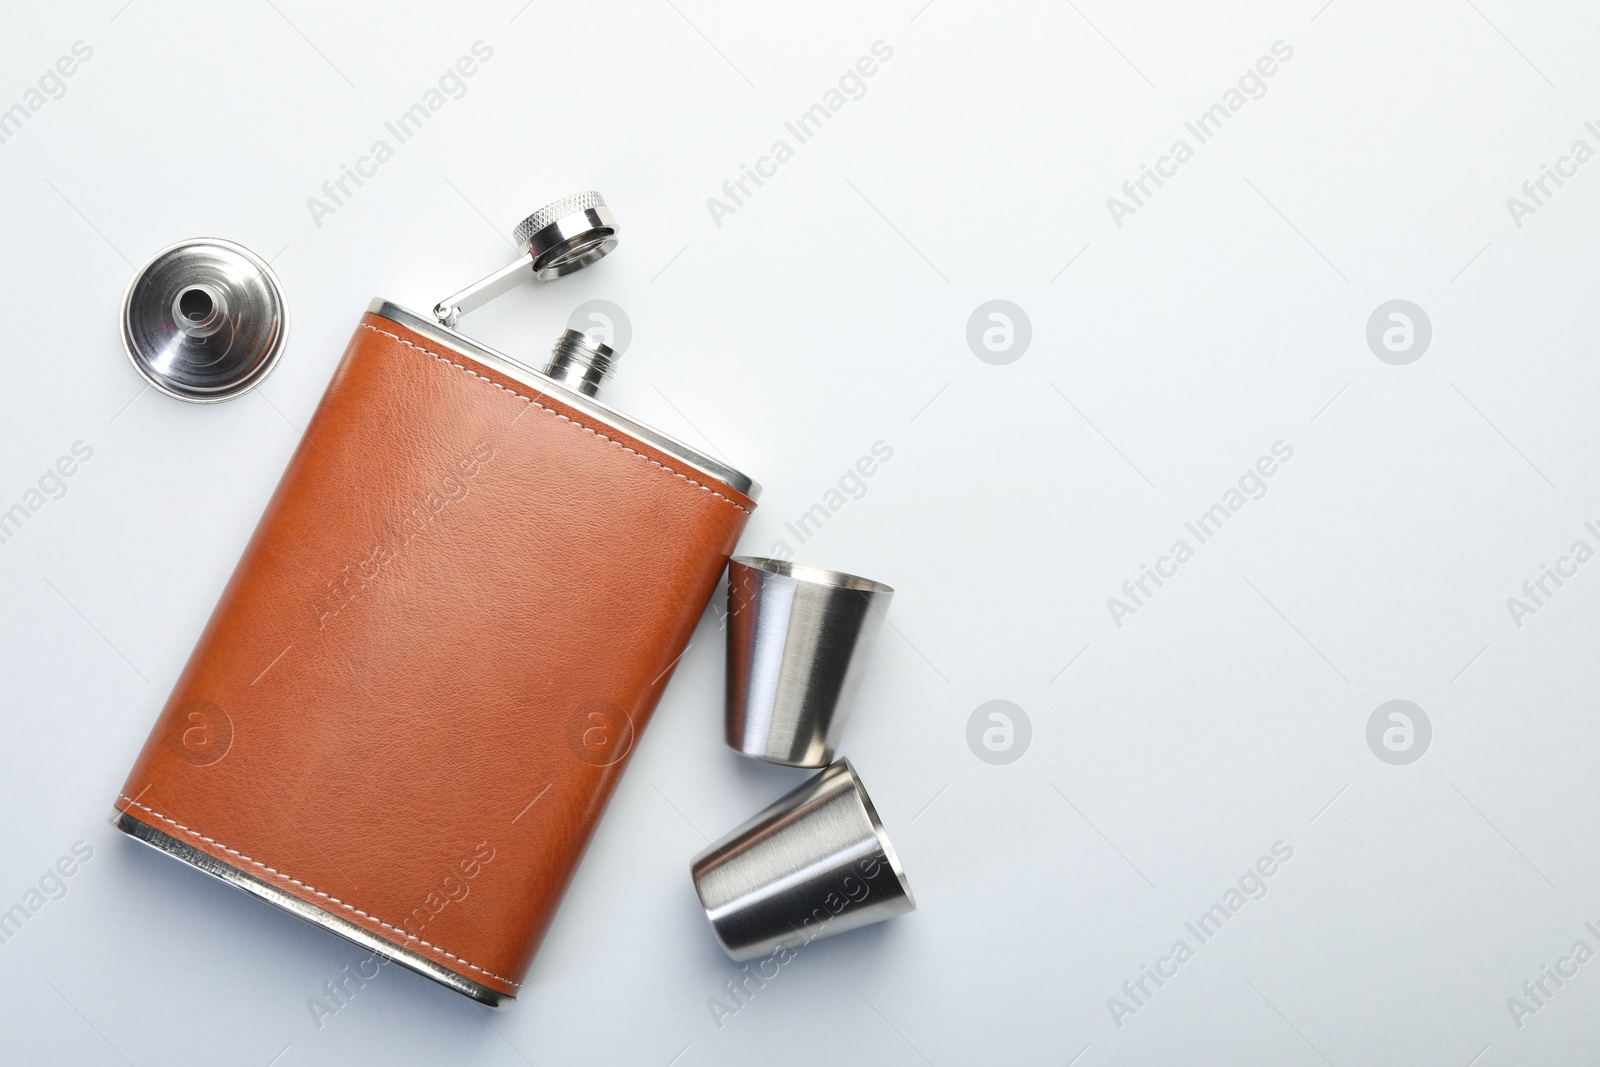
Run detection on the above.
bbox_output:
[726,555,894,766]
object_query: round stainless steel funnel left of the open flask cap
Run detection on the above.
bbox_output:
[122,237,290,403]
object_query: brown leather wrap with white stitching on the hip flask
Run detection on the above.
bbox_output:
[115,314,754,995]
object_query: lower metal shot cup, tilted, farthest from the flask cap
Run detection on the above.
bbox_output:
[690,760,917,961]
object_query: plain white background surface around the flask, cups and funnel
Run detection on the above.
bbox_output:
[0,0,1600,1067]
